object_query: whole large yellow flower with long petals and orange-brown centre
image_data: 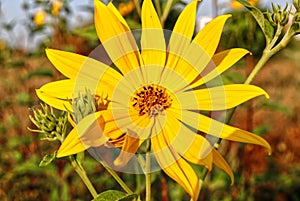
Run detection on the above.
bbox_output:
[37,0,271,200]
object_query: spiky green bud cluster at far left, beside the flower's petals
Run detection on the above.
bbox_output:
[28,105,68,142]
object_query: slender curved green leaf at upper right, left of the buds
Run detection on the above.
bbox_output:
[237,0,274,44]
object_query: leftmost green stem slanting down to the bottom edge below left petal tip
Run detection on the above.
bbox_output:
[69,156,98,198]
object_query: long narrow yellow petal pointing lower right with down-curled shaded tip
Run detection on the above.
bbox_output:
[182,111,271,154]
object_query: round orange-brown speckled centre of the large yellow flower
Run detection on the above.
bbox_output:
[131,84,172,118]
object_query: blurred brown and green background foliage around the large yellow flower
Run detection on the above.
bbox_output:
[0,0,300,201]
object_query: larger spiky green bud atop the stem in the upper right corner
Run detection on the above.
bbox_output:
[267,4,291,27]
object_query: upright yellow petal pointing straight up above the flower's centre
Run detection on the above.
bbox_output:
[141,0,166,66]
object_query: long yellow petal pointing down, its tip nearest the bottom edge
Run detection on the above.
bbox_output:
[151,133,200,201]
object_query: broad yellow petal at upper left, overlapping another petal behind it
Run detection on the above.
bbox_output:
[94,0,140,74]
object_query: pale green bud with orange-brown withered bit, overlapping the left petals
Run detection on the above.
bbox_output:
[71,89,109,123]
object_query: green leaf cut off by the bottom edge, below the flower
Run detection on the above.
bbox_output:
[93,190,138,201]
